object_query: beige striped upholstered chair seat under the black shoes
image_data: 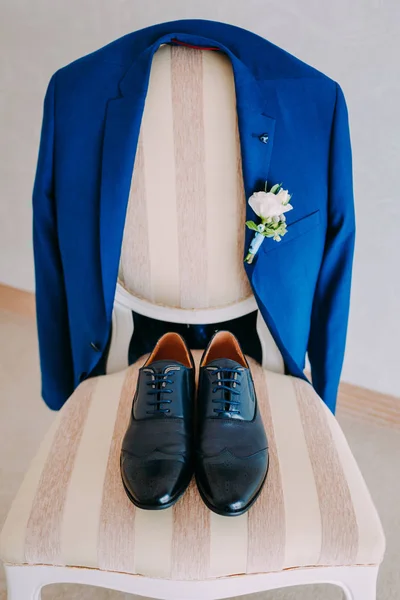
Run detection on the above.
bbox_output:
[0,352,385,580]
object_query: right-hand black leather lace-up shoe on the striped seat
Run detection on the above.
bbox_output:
[195,331,268,516]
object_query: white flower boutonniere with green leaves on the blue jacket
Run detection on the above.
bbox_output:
[244,182,293,264]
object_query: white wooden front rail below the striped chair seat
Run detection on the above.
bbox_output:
[5,565,378,600]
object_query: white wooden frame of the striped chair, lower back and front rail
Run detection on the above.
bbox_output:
[0,284,379,600]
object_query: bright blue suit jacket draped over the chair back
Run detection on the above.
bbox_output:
[33,20,355,410]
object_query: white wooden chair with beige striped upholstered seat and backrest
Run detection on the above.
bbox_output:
[0,46,385,600]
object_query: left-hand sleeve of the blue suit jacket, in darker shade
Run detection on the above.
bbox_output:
[32,73,73,410]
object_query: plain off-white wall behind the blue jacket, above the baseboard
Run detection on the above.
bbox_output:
[0,0,400,395]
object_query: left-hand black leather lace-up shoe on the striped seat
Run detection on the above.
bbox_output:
[121,333,195,510]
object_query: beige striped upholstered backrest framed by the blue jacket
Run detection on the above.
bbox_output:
[119,45,251,309]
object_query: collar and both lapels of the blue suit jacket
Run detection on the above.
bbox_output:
[100,33,275,320]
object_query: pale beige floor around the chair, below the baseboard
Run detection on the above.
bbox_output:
[0,311,400,600]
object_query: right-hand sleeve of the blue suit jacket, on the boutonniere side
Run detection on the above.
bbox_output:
[308,84,355,412]
